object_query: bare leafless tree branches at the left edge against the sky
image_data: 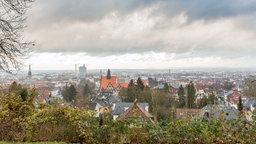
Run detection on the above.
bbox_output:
[0,0,34,73]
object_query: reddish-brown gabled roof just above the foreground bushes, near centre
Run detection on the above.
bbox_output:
[117,102,153,122]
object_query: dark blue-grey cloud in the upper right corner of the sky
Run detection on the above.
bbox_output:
[160,0,256,20]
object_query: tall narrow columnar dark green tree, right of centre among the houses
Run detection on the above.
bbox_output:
[187,81,196,108]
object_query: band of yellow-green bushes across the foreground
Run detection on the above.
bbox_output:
[0,86,256,143]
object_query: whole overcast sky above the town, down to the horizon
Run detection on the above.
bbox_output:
[24,0,256,70]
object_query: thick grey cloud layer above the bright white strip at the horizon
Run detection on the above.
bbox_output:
[25,0,256,58]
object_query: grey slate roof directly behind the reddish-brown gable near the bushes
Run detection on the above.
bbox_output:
[113,102,148,115]
